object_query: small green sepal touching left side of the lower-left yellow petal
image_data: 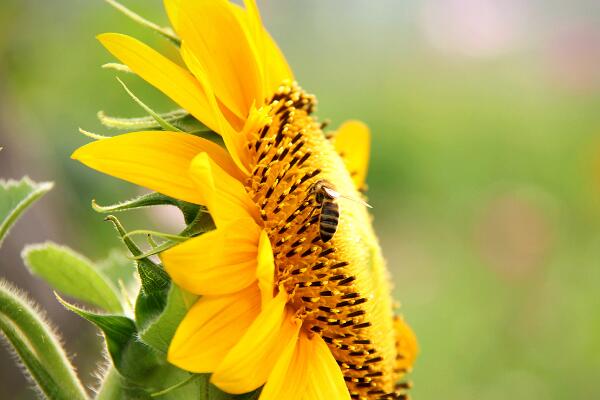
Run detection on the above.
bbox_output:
[140,284,198,354]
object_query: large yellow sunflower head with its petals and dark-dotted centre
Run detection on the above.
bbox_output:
[73,0,417,400]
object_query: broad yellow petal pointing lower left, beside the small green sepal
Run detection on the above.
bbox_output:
[168,285,260,373]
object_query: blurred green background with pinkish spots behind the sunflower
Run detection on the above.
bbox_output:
[0,0,600,400]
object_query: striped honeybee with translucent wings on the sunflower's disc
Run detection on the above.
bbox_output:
[309,180,372,243]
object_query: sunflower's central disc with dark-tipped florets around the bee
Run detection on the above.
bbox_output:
[246,83,408,400]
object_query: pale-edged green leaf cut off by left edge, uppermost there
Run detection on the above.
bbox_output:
[0,177,53,246]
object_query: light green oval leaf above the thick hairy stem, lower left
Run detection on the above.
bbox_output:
[21,242,123,313]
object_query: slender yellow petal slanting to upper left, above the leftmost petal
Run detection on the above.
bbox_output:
[98,33,225,131]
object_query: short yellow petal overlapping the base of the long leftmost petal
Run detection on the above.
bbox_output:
[190,153,258,227]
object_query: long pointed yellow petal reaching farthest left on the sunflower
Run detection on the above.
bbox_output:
[71,131,241,204]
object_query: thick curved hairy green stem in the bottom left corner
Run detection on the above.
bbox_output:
[0,280,87,400]
